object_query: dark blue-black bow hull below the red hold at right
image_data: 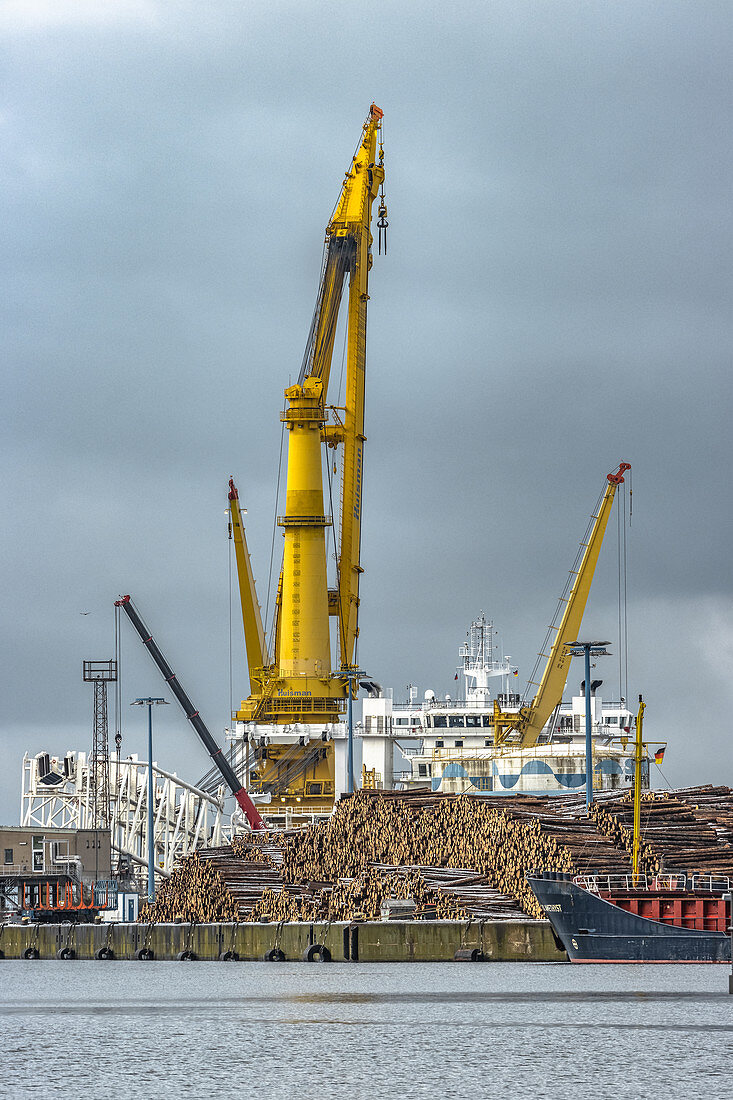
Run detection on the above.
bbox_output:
[527,875,731,963]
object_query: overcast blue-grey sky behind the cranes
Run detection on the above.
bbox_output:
[0,0,733,824]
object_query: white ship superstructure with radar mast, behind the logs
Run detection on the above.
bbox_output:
[359,613,648,794]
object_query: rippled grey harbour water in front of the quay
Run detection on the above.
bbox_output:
[0,961,733,1100]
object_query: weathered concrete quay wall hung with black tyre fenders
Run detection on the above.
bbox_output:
[0,920,567,963]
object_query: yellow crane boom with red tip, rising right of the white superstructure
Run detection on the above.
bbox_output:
[494,462,631,748]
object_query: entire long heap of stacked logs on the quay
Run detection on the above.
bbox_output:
[134,787,733,922]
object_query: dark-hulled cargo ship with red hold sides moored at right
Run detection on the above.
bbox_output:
[527,871,731,963]
